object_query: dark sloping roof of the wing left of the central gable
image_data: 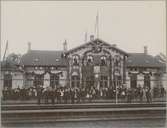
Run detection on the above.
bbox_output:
[21,50,67,66]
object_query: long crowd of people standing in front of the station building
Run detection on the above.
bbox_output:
[3,85,165,104]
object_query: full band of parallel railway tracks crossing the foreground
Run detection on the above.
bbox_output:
[1,103,166,124]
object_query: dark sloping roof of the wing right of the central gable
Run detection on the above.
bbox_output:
[127,53,165,68]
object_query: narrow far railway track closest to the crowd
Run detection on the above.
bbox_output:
[1,102,166,111]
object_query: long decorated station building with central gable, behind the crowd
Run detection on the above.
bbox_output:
[1,36,166,88]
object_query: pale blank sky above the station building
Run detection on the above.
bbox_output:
[1,1,166,56]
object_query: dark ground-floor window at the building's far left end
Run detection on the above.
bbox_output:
[4,74,12,88]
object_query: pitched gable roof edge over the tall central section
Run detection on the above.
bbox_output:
[66,38,128,56]
